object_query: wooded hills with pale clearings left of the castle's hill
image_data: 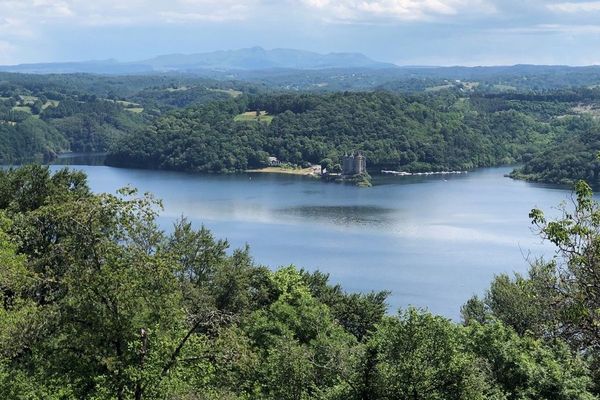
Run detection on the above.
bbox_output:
[0,73,256,164]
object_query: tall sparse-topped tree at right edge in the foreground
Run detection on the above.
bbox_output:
[462,181,600,393]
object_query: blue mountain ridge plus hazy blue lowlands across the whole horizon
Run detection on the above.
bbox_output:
[0,47,600,90]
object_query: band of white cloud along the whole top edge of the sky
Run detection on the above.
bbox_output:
[0,0,600,29]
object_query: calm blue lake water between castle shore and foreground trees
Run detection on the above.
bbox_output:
[52,166,570,318]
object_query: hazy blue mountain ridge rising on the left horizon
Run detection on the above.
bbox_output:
[0,47,396,74]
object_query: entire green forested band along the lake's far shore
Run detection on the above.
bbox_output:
[0,71,600,185]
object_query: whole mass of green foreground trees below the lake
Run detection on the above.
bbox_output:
[0,166,600,400]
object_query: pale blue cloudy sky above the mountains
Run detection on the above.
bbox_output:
[0,0,600,66]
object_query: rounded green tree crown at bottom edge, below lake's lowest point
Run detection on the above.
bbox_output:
[370,309,485,400]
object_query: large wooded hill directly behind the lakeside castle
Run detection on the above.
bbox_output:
[108,92,564,172]
